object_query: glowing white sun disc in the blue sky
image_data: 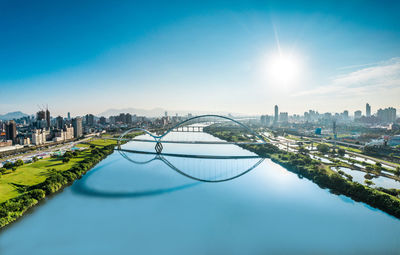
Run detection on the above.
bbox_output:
[267,53,300,85]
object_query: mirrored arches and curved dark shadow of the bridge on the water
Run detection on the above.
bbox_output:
[73,149,264,198]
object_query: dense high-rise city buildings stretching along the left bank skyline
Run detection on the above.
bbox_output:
[0,106,191,150]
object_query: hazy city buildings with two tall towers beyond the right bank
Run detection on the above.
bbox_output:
[260,103,400,146]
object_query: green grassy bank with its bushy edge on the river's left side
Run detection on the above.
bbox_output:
[0,139,116,228]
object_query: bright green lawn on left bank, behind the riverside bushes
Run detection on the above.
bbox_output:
[0,139,117,203]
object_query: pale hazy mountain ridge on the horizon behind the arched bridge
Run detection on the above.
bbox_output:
[98,108,243,118]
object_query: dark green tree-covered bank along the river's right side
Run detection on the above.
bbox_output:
[204,126,400,219]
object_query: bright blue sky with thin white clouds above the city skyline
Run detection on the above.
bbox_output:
[0,0,400,116]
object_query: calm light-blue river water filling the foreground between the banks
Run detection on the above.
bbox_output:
[0,134,400,255]
